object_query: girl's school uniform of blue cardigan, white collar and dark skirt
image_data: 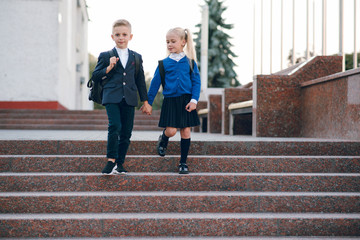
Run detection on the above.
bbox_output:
[148,52,201,128]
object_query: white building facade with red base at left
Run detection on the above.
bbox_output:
[0,0,93,110]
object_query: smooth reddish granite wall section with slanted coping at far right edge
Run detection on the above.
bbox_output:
[301,68,360,139]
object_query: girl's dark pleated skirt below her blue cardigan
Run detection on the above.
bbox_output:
[159,94,200,128]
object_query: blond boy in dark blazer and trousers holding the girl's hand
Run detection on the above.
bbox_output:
[93,19,148,174]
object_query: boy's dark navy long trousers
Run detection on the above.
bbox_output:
[105,99,135,164]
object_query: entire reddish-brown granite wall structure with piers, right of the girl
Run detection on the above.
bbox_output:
[198,56,360,139]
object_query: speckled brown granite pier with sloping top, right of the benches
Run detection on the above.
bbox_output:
[253,56,342,137]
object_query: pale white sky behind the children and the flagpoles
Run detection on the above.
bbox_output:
[86,0,360,84]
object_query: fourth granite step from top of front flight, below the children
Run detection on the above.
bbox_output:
[0,191,360,214]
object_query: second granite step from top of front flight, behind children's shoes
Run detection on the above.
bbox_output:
[0,155,360,173]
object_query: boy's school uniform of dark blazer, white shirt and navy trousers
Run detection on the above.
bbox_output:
[93,47,147,164]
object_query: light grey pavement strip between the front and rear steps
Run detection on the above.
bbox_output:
[0,130,354,142]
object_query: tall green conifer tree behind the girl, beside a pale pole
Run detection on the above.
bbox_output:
[195,0,240,87]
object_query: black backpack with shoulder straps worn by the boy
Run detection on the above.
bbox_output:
[87,50,140,104]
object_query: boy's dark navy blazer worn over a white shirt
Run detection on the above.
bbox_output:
[92,48,147,107]
